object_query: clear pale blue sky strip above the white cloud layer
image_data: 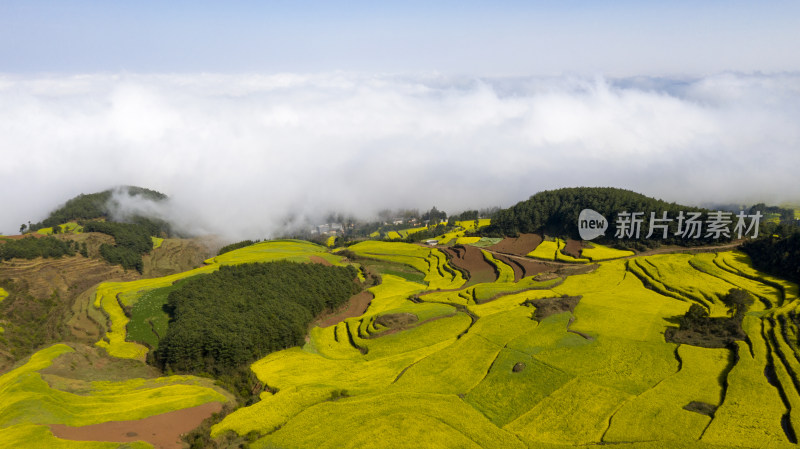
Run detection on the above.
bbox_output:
[0,0,800,76]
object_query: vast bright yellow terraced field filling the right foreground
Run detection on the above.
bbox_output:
[213,242,800,448]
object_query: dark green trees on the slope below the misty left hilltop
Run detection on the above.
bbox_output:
[83,221,153,273]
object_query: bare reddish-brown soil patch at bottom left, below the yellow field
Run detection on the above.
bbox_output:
[50,402,222,449]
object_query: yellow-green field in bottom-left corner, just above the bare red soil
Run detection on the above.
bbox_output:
[0,344,229,448]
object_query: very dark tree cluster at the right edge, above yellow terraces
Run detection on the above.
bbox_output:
[740,227,800,282]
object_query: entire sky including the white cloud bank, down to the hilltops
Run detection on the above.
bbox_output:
[0,0,800,236]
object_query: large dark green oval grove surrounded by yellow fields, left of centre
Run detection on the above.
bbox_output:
[153,261,361,376]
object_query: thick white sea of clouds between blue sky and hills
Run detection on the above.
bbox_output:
[0,73,800,238]
